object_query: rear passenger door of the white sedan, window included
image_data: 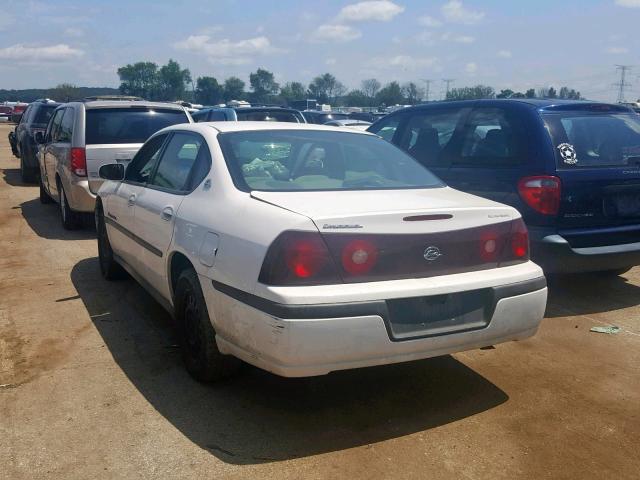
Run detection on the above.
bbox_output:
[133,132,211,298]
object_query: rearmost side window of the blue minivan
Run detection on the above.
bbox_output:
[453,108,525,166]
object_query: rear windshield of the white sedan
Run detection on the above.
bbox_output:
[218,130,444,191]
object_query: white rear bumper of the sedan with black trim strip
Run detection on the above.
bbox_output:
[201,277,547,377]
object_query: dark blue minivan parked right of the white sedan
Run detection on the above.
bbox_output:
[368,99,640,274]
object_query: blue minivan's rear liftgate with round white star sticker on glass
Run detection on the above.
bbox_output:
[543,111,640,234]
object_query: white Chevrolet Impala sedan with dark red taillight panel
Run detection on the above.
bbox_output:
[96,122,547,381]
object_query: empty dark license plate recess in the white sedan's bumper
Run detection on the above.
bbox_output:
[387,289,493,340]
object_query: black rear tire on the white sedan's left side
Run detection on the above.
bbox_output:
[174,269,240,382]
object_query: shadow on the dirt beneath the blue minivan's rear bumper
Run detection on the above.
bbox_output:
[545,272,640,318]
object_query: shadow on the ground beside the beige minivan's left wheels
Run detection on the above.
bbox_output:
[18,198,96,240]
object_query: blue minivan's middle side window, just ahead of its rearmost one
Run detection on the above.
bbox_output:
[400,108,468,166]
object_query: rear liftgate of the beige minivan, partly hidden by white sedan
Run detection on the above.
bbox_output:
[85,106,189,193]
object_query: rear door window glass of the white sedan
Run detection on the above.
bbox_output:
[149,132,208,192]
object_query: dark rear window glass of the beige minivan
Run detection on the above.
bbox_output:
[85,108,189,145]
